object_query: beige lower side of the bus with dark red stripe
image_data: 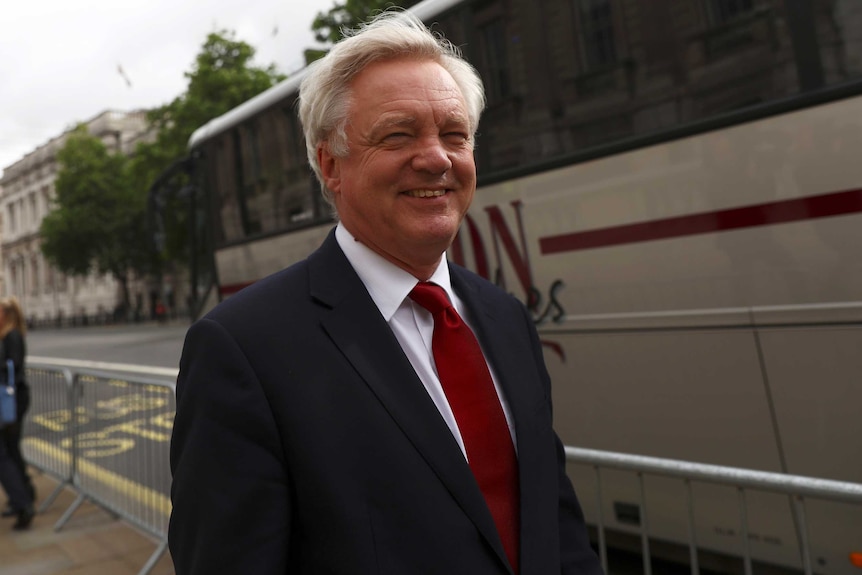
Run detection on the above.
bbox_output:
[451,98,862,575]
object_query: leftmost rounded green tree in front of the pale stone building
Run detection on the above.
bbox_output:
[40,125,151,318]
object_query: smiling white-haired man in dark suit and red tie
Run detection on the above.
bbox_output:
[169,13,601,575]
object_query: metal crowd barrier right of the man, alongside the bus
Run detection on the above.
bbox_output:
[565,446,862,575]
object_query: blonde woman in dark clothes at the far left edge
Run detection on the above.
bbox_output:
[0,296,35,530]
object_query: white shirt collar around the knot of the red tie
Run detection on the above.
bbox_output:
[335,223,455,322]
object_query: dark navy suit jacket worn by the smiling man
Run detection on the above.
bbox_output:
[169,234,601,575]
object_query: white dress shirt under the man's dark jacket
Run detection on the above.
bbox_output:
[335,223,517,458]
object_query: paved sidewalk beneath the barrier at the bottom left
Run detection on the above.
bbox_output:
[0,470,174,575]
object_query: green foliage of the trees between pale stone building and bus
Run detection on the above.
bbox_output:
[41,31,284,316]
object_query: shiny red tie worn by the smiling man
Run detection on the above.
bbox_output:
[410,282,520,573]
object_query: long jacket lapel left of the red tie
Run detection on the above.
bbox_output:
[308,233,505,559]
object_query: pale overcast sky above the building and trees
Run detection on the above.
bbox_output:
[0,0,335,174]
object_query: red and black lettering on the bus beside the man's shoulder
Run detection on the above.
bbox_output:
[451,200,565,361]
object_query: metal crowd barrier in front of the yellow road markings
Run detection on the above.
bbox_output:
[22,361,176,575]
